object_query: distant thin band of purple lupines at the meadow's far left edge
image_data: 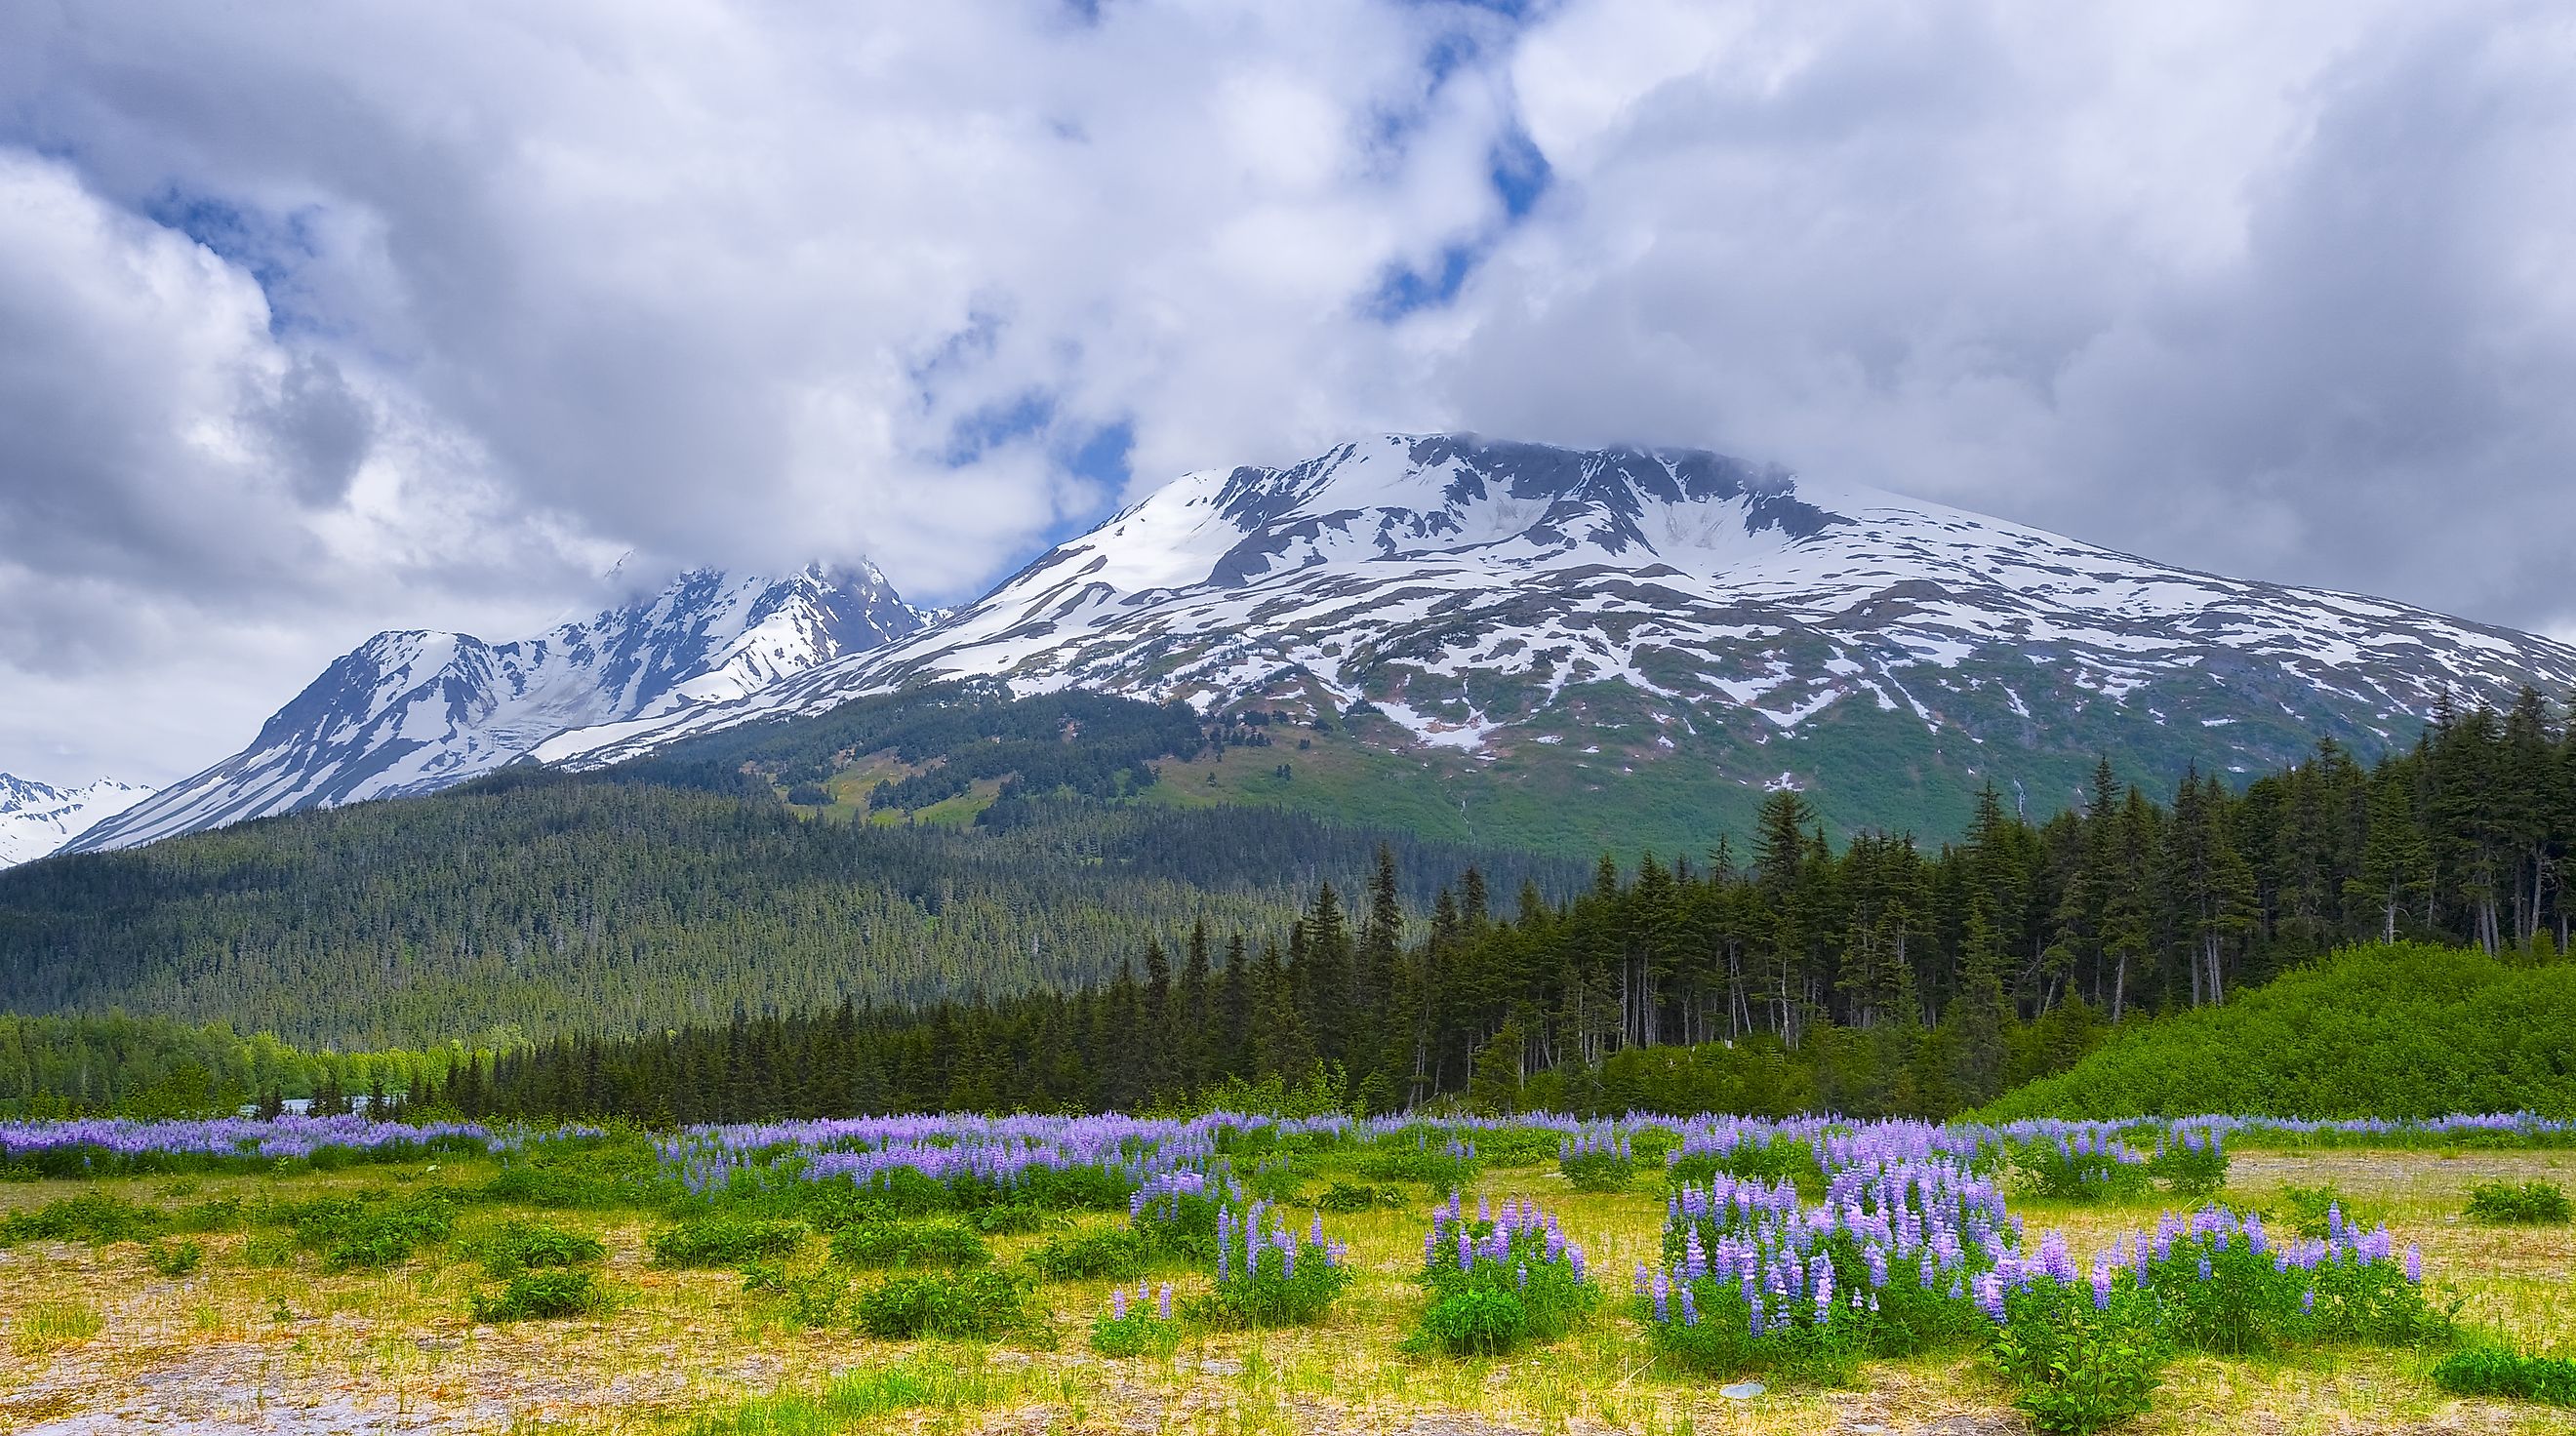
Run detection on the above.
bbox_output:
[0,1117,500,1177]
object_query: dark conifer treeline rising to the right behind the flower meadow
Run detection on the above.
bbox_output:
[448,695,2576,1120]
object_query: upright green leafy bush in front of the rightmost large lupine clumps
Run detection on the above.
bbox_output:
[1992,1276,2169,1433]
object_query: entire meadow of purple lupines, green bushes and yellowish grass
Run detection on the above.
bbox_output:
[0,1114,2576,1436]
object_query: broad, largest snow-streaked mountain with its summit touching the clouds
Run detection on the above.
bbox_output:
[539,435,2576,803]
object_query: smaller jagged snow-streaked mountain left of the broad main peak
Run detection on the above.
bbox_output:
[64,564,922,852]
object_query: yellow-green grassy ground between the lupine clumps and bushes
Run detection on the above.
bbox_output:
[0,1150,2576,1436]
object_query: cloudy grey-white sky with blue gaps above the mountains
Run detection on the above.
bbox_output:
[0,0,2576,782]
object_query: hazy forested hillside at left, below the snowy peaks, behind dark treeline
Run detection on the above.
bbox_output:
[0,700,1579,1050]
